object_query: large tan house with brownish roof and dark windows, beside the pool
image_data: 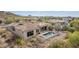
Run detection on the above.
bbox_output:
[6,22,48,39]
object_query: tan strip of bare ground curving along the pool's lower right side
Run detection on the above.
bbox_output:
[36,31,67,48]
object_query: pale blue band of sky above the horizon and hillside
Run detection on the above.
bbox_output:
[10,11,79,17]
